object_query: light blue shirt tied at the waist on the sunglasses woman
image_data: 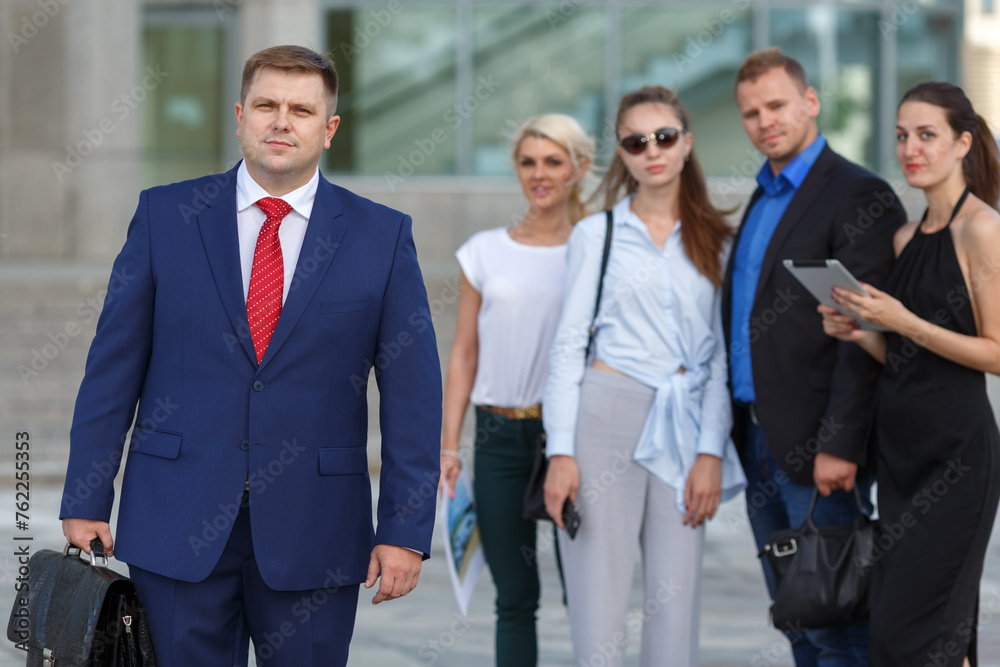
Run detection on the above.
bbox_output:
[543,197,746,512]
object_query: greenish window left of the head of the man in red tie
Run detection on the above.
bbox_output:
[143,24,227,187]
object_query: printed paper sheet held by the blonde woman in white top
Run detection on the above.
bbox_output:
[440,462,486,616]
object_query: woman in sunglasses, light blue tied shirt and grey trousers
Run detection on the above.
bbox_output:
[544,87,745,667]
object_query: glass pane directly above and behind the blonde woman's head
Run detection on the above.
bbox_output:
[472,9,605,174]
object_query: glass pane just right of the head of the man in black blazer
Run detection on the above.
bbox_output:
[770,7,883,169]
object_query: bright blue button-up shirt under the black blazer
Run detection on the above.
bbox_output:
[729,134,826,403]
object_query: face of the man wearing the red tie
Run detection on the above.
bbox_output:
[236,69,340,197]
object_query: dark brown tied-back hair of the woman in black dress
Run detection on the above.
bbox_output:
[899,81,1000,209]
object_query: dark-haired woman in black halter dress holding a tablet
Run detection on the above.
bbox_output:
[820,82,1000,667]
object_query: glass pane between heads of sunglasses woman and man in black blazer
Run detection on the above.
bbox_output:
[611,8,756,176]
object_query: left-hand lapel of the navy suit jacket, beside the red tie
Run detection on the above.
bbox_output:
[198,165,257,363]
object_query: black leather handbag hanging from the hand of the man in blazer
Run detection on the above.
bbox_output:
[760,487,876,630]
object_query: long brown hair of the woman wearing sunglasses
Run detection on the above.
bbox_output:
[591,86,732,287]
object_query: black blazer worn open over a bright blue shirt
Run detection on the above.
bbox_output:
[722,146,906,485]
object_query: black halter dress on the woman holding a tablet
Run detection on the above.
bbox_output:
[870,189,1000,667]
